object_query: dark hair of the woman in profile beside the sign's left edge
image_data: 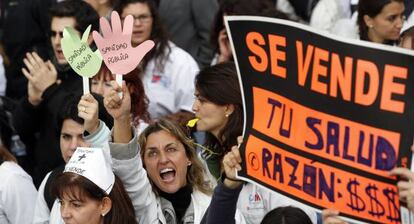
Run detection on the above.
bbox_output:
[195,62,244,153]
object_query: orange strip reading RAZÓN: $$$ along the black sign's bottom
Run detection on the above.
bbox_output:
[244,135,399,223]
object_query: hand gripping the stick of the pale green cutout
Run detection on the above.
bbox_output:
[78,94,99,134]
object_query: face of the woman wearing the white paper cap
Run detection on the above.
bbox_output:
[59,187,106,224]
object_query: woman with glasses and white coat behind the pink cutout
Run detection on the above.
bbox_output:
[115,0,198,124]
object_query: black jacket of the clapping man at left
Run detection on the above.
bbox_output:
[13,70,82,186]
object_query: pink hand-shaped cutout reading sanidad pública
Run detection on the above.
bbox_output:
[92,11,155,75]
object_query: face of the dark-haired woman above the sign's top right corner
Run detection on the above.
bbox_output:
[364,1,405,43]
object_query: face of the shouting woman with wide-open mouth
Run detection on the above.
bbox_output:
[143,130,191,193]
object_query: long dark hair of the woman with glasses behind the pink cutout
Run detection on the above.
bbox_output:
[114,0,171,71]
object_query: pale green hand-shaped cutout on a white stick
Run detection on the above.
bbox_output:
[61,25,102,94]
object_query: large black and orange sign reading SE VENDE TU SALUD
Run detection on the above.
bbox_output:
[226,16,414,223]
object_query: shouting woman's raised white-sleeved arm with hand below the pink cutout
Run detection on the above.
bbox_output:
[104,82,165,224]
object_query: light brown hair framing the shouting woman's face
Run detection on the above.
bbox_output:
[138,119,212,194]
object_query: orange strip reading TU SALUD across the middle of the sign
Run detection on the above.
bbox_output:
[253,87,400,178]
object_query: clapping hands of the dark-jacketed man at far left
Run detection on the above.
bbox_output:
[22,52,57,106]
